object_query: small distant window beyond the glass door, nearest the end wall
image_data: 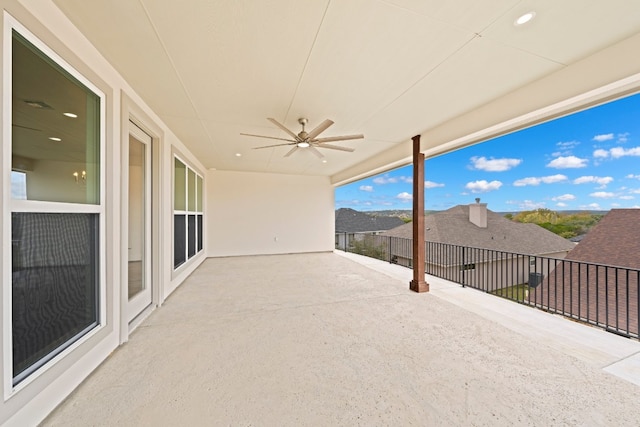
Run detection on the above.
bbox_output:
[173,157,203,269]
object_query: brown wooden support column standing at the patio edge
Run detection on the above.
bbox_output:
[409,135,429,292]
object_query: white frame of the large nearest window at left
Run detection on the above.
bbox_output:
[0,11,107,400]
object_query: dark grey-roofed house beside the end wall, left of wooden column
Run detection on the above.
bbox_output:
[336,208,404,249]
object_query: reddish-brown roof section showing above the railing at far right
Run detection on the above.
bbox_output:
[567,209,640,269]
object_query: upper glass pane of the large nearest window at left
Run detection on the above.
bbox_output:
[12,32,100,204]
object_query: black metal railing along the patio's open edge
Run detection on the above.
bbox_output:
[336,233,640,338]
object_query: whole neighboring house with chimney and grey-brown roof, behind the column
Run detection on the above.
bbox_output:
[382,202,575,287]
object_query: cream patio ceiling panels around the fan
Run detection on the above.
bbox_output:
[54,0,640,181]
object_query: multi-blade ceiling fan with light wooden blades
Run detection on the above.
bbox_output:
[240,118,364,159]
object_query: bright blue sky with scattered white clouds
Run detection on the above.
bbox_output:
[335,94,640,212]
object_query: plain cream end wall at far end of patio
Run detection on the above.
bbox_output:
[205,171,335,257]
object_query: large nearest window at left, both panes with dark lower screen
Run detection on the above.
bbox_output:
[11,30,104,385]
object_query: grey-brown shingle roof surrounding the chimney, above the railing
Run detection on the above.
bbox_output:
[382,205,575,255]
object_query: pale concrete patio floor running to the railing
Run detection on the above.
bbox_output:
[43,253,640,426]
